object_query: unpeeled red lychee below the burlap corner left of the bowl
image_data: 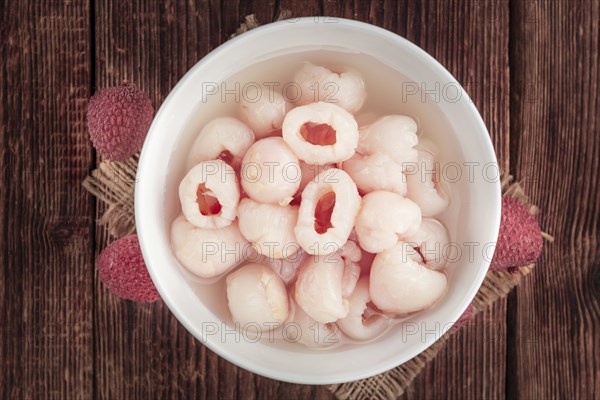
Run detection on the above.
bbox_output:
[96,235,160,303]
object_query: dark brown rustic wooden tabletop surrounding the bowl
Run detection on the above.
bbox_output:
[0,0,600,399]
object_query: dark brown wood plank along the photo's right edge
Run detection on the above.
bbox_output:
[507,0,600,398]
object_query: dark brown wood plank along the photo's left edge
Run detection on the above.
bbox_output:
[0,1,93,398]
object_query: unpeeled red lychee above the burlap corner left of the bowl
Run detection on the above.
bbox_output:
[87,83,154,161]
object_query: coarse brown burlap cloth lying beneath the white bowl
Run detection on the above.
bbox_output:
[83,10,553,400]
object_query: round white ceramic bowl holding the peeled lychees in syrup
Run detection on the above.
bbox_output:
[135,17,501,384]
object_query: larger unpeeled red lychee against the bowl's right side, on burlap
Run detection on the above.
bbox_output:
[490,196,543,271]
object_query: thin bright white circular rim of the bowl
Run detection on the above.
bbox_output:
[134,16,501,384]
